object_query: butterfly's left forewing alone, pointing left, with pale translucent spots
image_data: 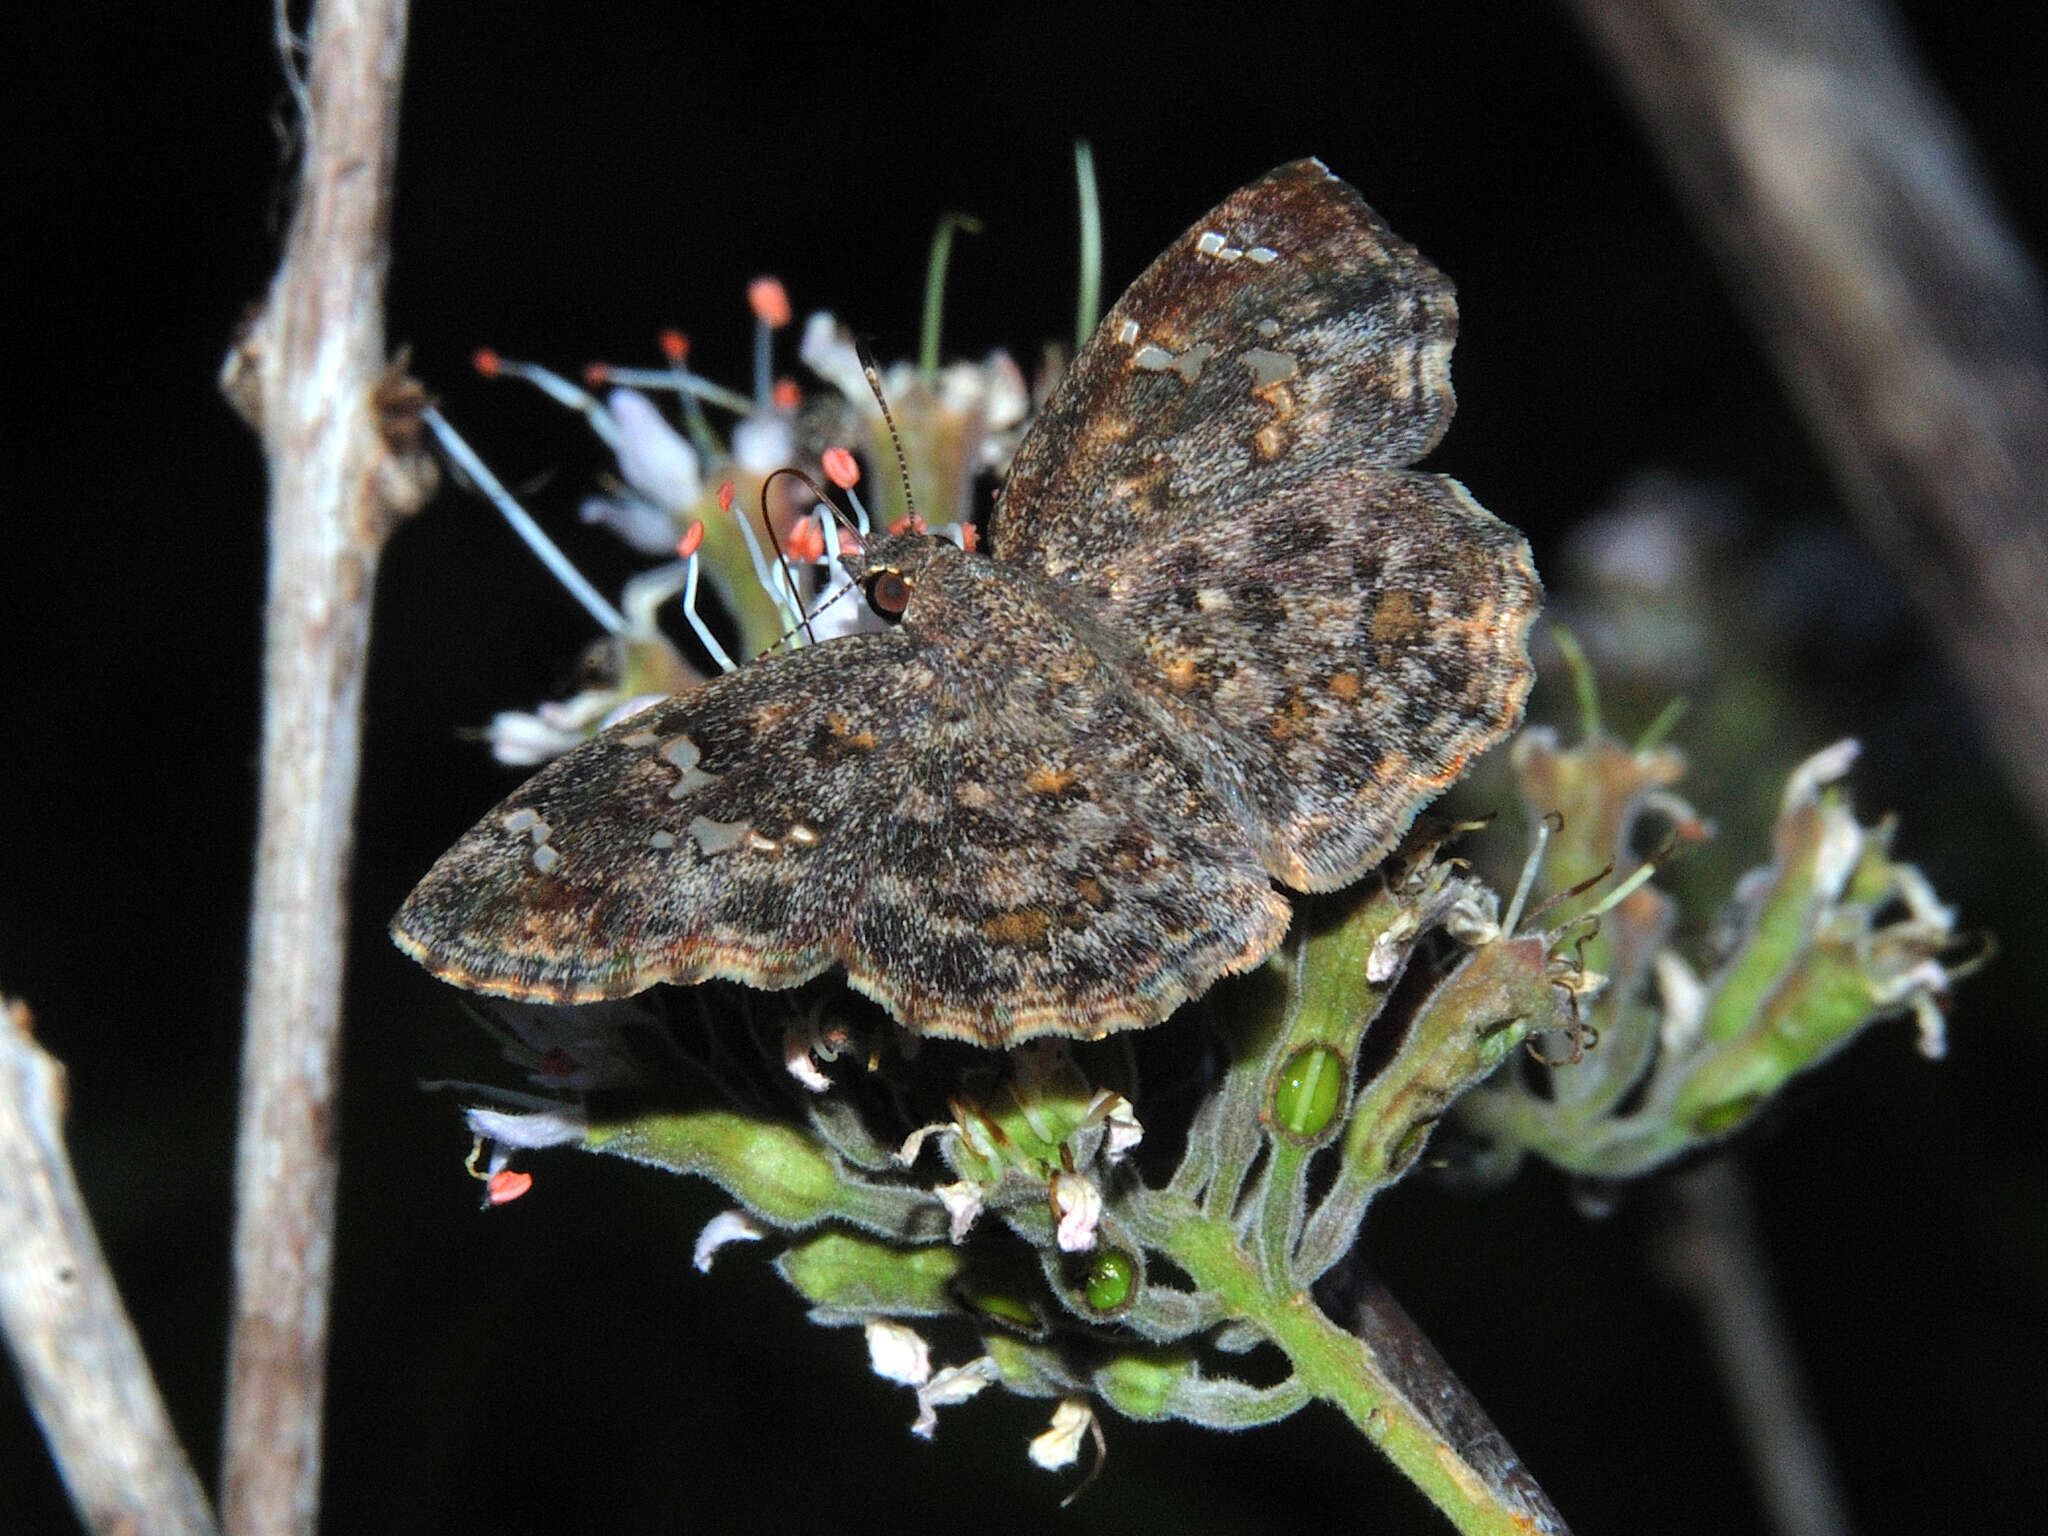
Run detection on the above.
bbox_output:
[393,631,924,1001]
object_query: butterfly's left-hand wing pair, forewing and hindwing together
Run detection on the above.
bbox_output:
[393,606,1286,1044]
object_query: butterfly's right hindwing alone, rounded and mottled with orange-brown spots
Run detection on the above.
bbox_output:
[1090,469,1542,891]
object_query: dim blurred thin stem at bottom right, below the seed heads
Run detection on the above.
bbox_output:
[1659,1157,1851,1536]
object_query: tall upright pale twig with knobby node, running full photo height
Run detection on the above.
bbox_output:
[221,0,432,1536]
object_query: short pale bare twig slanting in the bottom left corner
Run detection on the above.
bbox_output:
[0,1001,213,1536]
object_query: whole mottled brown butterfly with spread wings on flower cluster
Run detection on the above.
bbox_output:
[391,160,1542,1047]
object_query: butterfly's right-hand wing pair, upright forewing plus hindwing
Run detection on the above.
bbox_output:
[991,160,1542,891]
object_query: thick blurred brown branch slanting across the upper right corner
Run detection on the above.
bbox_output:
[1573,0,2048,843]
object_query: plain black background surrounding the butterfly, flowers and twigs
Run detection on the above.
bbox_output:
[0,4,2048,1534]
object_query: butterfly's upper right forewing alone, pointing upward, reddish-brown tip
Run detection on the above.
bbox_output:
[989,160,1458,575]
